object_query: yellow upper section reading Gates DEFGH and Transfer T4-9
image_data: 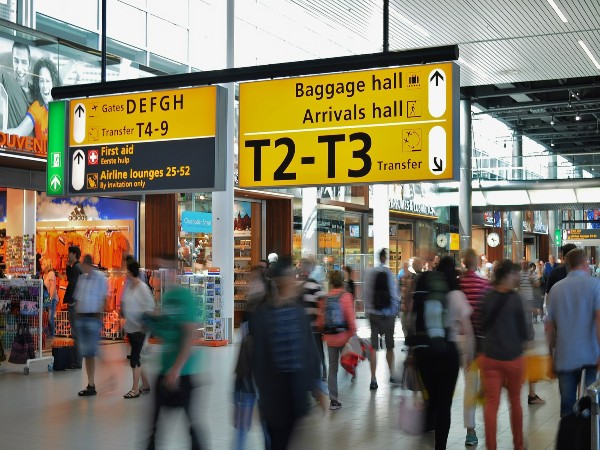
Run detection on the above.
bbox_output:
[69,86,217,147]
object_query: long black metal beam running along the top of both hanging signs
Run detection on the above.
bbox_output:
[52,45,458,100]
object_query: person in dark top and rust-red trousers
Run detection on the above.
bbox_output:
[479,259,527,450]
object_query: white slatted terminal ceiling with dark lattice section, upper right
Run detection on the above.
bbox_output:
[289,0,600,165]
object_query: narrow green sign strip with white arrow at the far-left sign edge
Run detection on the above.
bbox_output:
[46,101,68,196]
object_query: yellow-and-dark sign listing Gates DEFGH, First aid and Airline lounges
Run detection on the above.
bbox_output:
[47,86,226,195]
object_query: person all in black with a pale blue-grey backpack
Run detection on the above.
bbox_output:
[406,256,474,450]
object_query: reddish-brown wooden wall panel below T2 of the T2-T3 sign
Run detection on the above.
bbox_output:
[265,199,292,259]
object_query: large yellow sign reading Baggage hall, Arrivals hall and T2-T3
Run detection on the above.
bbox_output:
[239,63,460,187]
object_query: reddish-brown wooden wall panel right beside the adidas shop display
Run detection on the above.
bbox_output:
[145,194,179,269]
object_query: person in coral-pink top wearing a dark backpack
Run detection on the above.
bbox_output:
[317,270,356,410]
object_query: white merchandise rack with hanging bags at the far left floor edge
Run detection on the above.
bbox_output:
[0,278,54,375]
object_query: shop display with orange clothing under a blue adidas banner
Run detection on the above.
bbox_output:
[0,188,139,338]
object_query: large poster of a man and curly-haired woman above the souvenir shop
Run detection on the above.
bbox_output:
[0,30,152,160]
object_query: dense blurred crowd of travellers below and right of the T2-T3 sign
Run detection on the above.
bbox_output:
[235,244,600,450]
